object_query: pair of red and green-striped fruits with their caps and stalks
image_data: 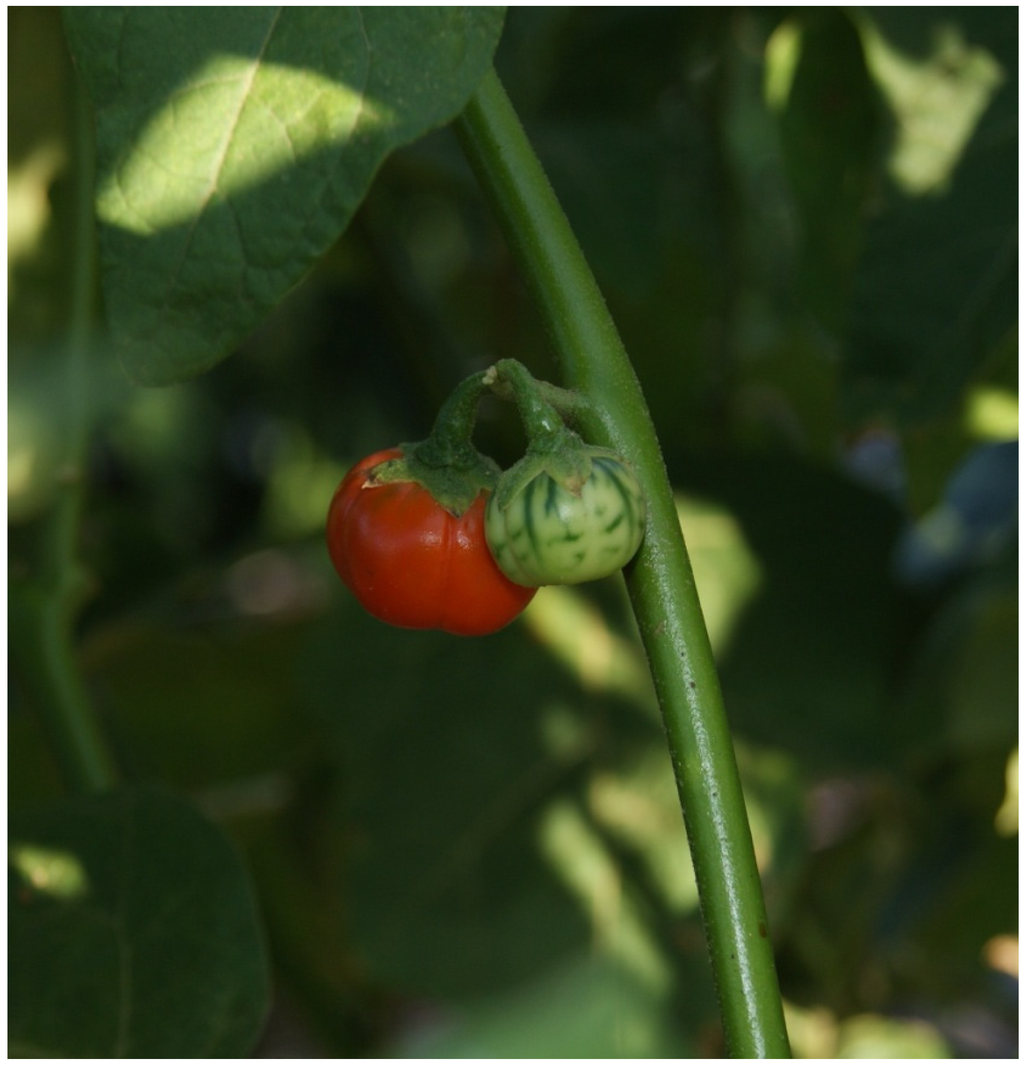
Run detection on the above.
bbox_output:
[326,361,646,636]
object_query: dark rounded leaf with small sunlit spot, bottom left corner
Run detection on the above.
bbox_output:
[7,790,268,1057]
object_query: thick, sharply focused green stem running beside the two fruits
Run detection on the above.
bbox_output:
[455,70,789,1056]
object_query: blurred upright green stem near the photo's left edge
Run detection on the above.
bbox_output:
[10,52,116,792]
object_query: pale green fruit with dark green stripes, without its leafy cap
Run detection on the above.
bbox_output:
[484,449,646,586]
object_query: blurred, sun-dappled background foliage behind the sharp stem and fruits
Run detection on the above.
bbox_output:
[7,7,1018,1057]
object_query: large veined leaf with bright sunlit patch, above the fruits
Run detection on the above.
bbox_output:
[66,7,502,384]
